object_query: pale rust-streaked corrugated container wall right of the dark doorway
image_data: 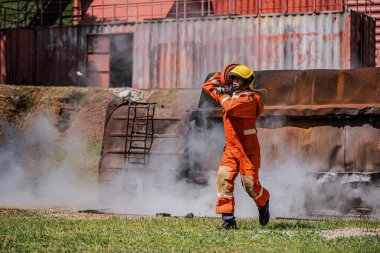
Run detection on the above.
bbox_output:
[133,13,374,89]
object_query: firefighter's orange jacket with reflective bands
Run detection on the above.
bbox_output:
[203,73,264,164]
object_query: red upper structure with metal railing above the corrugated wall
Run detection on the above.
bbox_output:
[0,0,373,28]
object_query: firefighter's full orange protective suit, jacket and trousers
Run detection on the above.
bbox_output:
[203,73,269,214]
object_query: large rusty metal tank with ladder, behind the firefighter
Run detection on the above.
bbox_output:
[99,68,380,214]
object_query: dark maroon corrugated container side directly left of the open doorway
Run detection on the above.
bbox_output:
[36,24,134,87]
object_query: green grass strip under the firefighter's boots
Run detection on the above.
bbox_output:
[0,209,380,252]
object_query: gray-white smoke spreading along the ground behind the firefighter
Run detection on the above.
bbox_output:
[0,105,380,217]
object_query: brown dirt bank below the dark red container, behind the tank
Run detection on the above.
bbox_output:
[0,84,200,181]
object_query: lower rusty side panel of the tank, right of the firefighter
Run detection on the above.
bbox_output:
[258,123,380,173]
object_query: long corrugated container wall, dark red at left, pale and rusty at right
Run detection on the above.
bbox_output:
[1,10,375,89]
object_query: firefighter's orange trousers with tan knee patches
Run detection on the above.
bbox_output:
[216,148,269,213]
